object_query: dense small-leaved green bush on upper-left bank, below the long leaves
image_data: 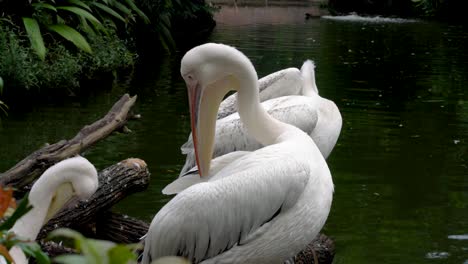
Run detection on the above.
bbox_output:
[0,25,135,91]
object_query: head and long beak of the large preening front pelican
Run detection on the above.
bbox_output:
[180,43,257,177]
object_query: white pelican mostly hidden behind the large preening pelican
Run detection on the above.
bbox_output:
[179,60,342,177]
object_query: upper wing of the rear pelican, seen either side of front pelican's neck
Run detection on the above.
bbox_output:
[218,68,302,119]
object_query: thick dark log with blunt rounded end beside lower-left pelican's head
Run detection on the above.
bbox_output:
[39,159,150,237]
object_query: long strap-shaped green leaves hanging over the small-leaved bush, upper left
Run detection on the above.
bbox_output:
[18,0,149,60]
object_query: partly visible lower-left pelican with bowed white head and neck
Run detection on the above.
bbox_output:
[0,156,98,264]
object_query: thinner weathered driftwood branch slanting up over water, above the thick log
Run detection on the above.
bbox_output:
[0,94,136,194]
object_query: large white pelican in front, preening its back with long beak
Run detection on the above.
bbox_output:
[142,43,333,264]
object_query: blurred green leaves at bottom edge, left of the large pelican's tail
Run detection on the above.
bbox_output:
[49,229,141,264]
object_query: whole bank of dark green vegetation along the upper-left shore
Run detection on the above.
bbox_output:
[0,0,215,110]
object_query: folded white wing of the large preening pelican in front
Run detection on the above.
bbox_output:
[143,156,310,263]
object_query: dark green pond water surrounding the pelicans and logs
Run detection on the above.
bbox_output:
[0,4,468,264]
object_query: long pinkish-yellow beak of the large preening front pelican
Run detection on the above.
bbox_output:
[187,78,231,177]
